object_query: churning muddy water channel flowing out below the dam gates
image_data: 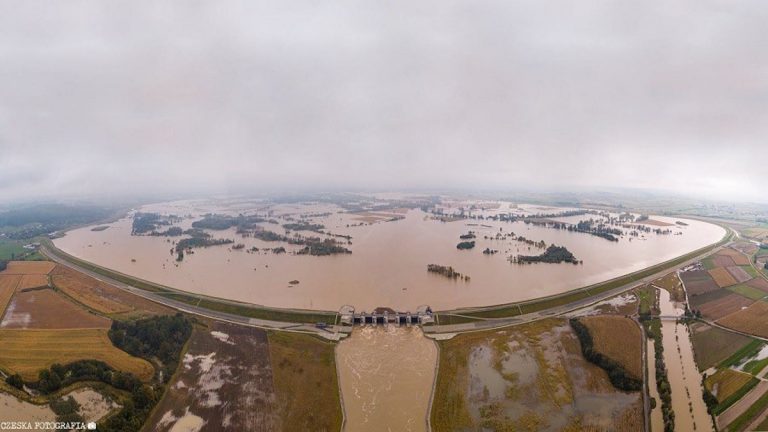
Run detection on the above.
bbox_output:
[336,325,437,432]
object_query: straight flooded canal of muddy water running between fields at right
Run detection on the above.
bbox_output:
[659,289,714,431]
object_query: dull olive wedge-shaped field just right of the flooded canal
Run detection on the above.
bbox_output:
[690,322,751,371]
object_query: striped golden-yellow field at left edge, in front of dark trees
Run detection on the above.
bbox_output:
[0,329,154,381]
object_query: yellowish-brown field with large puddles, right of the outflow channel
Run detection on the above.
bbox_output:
[431,317,643,431]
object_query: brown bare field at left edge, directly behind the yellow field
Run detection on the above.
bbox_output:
[0,288,112,329]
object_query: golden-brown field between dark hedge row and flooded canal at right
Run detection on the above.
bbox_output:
[580,315,643,379]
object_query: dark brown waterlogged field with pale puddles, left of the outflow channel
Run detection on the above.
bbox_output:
[145,323,280,432]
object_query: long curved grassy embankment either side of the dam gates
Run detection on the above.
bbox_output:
[41,221,733,333]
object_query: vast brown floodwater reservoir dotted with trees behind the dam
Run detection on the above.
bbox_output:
[55,201,724,311]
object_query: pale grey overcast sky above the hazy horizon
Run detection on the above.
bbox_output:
[0,0,768,202]
